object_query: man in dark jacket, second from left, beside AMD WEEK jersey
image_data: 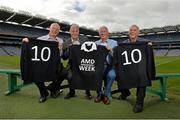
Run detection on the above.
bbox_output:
[57,24,92,99]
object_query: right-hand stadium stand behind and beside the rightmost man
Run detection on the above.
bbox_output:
[111,25,180,56]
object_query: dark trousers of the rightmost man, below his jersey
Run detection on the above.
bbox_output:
[120,87,146,104]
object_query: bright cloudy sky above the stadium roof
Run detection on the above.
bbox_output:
[0,0,180,32]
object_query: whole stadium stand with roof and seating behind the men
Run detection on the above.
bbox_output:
[0,6,180,56]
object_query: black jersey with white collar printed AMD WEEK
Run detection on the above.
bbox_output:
[69,42,108,90]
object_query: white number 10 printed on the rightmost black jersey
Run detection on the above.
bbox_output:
[121,49,142,65]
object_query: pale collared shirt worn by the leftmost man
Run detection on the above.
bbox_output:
[37,35,63,44]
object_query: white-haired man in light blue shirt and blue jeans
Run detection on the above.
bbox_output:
[95,26,117,105]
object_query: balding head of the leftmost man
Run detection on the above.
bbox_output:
[49,23,60,38]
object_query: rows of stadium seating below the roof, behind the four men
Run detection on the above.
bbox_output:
[0,22,180,56]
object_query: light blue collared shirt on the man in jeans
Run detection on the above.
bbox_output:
[95,39,118,64]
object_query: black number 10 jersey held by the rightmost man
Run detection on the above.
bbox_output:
[114,42,155,89]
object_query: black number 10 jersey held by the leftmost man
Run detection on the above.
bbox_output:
[20,39,60,84]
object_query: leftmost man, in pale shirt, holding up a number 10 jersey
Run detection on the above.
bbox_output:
[22,23,63,103]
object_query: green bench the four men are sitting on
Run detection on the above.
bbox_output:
[0,69,180,101]
